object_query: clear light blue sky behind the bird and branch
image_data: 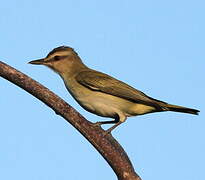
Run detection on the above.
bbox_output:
[0,0,205,180]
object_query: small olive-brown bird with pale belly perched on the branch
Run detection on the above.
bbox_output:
[29,46,199,133]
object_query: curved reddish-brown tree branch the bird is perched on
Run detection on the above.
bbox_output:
[0,61,141,180]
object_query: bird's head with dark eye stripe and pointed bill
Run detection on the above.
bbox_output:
[29,46,83,74]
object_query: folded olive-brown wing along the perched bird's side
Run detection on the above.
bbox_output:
[76,70,165,109]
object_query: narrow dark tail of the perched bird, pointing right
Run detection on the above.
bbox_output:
[165,104,199,115]
